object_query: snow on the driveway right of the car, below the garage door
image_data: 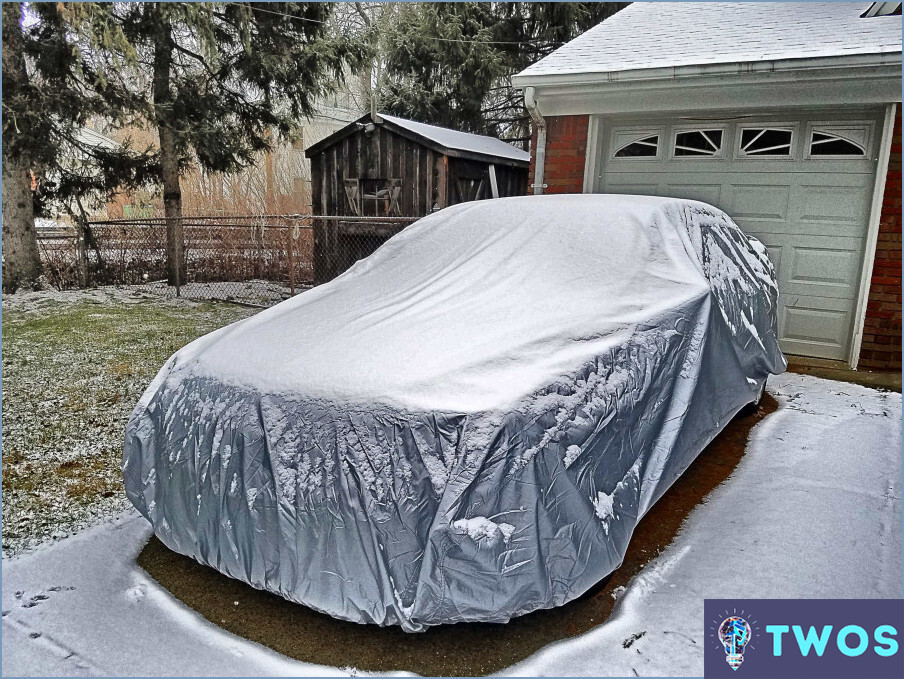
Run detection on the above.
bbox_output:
[506,373,902,677]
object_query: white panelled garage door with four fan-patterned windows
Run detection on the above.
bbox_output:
[597,112,881,360]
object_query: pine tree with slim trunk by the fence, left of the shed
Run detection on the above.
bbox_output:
[67,2,359,285]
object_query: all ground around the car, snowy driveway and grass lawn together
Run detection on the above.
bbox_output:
[2,292,902,676]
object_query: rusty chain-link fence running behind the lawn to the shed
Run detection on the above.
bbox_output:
[38,215,415,306]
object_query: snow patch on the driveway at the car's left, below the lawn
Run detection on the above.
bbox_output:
[2,511,370,677]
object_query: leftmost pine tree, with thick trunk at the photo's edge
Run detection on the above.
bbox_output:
[3,3,154,292]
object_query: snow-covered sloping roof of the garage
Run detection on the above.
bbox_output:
[514,2,901,86]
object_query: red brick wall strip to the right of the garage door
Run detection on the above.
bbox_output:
[858,109,901,370]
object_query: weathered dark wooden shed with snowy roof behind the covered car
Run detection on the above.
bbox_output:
[305,115,530,283]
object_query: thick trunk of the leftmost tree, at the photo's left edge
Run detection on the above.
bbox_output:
[3,3,41,293]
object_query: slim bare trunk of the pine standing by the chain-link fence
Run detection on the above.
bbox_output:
[154,13,185,294]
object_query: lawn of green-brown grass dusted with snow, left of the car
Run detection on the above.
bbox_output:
[3,288,256,556]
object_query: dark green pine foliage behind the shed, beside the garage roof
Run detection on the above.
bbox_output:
[380,2,627,143]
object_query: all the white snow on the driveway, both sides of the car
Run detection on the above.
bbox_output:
[2,373,902,676]
